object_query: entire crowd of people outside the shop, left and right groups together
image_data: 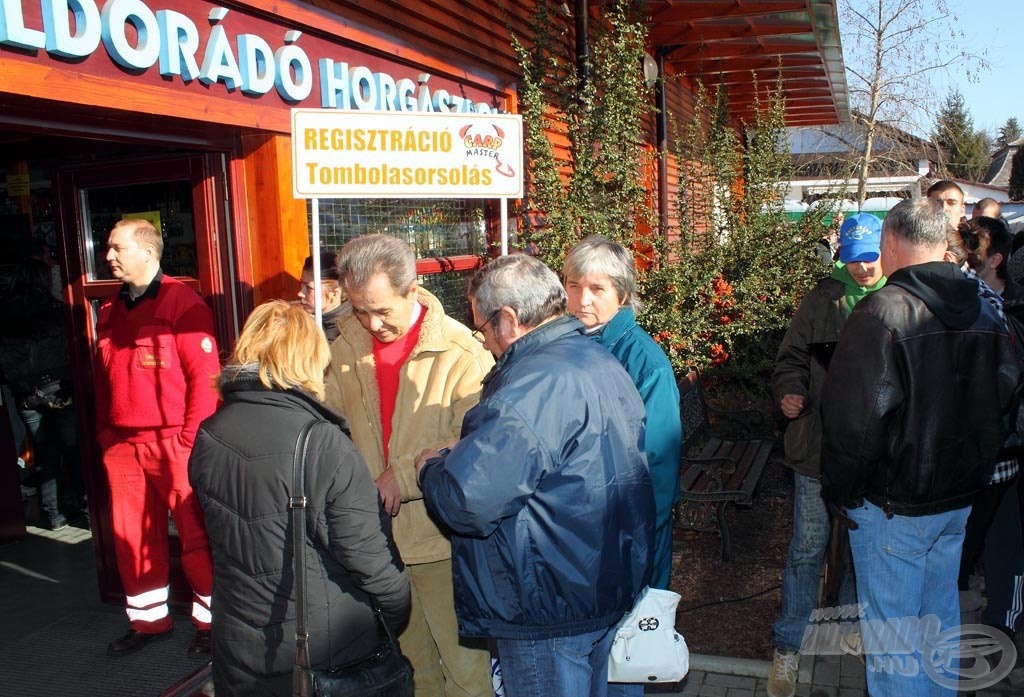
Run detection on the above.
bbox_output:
[4,182,1024,697]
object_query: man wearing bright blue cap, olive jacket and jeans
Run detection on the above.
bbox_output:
[768,213,886,697]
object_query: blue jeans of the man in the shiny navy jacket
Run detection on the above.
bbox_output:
[497,626,615,697]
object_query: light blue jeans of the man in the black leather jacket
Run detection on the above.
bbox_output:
[847,502,971,697]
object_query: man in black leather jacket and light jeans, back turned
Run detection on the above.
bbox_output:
[822,200,1021,697]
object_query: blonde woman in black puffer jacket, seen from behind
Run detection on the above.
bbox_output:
[188,301,410,697]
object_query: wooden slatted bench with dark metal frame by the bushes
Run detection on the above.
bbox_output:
[677,367,775,561]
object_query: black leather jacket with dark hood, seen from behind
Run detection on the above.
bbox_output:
[822,262,1021,516]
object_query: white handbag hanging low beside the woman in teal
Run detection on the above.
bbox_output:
[608,587,690,683]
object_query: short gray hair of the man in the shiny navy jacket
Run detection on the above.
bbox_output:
[469,254,567,326]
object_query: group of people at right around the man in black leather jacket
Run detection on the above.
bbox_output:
[767,180,1024,697]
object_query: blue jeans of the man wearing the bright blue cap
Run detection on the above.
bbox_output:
[772,473,855,651]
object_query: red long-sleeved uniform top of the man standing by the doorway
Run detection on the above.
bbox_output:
[95,276,220,447]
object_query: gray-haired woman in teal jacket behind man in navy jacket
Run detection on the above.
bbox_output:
[562,235,683,589]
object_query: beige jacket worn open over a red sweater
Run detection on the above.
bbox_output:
[326,288,495,564]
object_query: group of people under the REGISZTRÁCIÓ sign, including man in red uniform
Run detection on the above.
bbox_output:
[74,220,682,697]
